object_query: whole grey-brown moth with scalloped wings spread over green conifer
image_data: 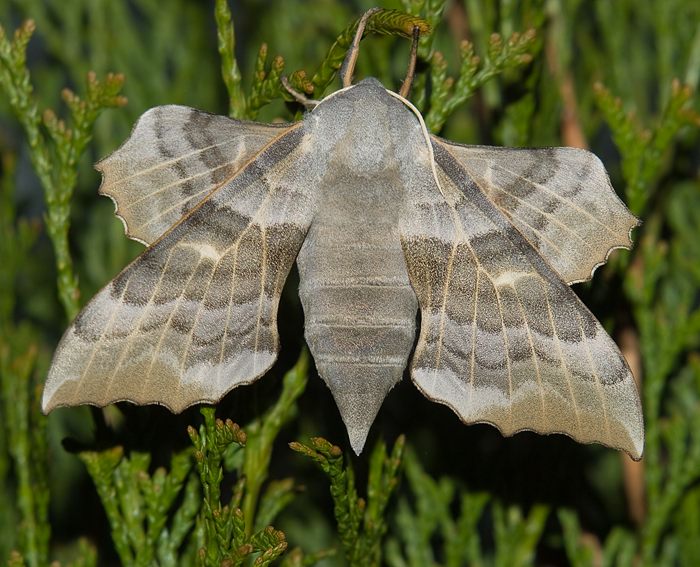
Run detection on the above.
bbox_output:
[43,13,644,459]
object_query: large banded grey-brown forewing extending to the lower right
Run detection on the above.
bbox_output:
[402,143,644,458]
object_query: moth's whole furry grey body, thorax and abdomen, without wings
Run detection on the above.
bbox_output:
[297,80,425,453]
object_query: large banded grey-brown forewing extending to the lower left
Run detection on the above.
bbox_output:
[43,128,315,412]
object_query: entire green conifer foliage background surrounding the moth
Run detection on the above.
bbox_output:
[0,0,700,566]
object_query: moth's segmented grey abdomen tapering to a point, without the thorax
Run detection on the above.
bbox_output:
[297,192,417,451]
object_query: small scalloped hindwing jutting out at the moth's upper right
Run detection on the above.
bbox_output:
[433,138,639,284]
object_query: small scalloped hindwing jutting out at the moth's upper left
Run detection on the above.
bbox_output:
[95,105,290,244]
